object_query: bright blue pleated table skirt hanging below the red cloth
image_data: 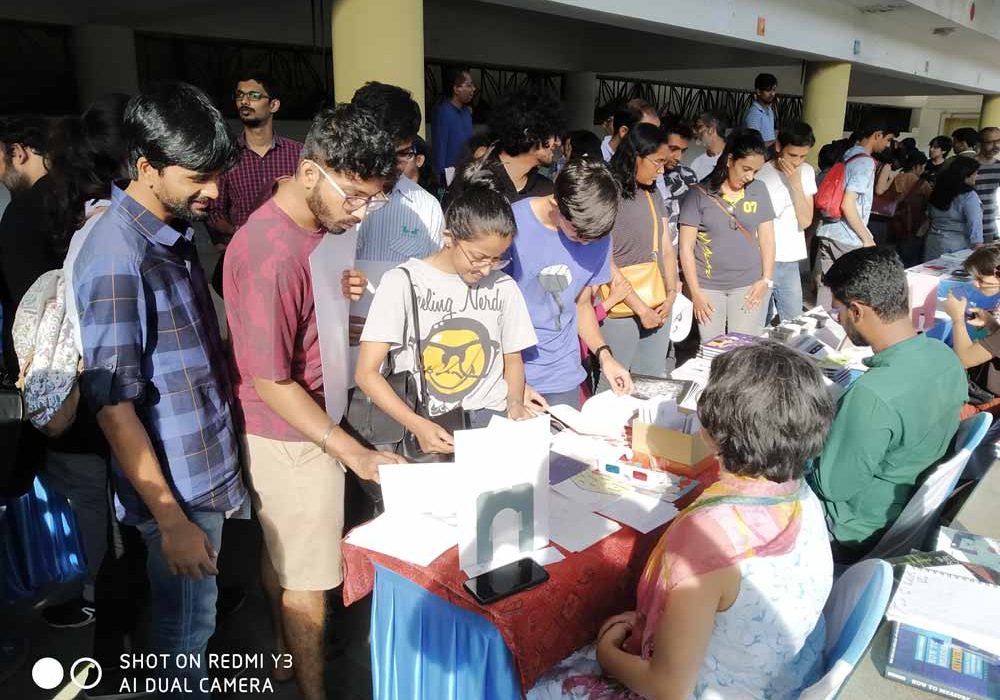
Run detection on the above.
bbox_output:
[371,564,521,700]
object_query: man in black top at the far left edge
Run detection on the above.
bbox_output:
[0,116,55,376]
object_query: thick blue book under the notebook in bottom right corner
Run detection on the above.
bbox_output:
[885,622,1000,700]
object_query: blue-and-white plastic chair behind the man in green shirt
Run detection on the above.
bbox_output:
[865,413,993,559]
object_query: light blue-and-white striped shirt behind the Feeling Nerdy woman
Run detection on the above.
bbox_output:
[357,177,444,264]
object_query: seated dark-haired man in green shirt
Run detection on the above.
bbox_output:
[808,248,968,562]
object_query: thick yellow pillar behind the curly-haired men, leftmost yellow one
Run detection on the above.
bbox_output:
[331,0,427,132]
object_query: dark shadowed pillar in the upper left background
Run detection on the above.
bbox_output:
[72,24,139,111]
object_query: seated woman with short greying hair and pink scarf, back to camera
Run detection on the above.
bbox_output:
[528,342,833,700]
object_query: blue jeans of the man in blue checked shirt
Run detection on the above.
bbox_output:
[139,513,226,700]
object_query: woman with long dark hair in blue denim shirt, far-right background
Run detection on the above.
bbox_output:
[924,156,983,260]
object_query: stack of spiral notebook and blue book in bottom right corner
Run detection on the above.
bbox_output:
[885,528,1000,700]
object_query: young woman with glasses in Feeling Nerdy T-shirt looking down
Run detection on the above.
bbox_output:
[355,173,535,453]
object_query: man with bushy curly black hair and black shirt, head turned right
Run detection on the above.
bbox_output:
[449,90,566,204]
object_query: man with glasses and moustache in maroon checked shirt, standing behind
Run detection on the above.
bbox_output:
[208,72,302,254]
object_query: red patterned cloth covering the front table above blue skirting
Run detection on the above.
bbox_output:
[343,466,718,691]
